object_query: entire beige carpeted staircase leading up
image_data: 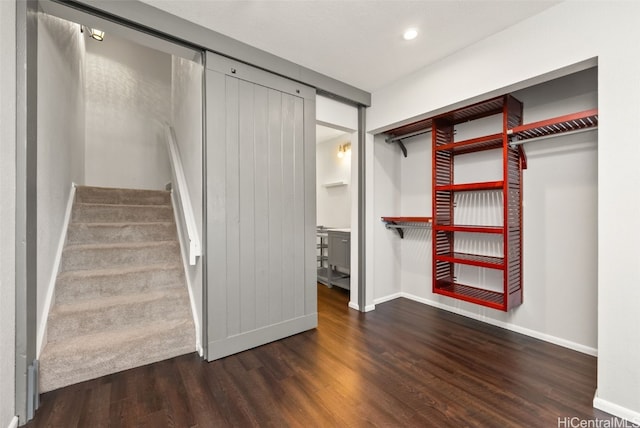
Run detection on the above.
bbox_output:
[40,187,196,392]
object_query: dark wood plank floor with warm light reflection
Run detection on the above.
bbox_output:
[26,286,610,428]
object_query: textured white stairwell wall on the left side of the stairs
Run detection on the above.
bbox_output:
[37,15,84,354]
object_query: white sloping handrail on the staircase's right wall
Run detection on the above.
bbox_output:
[165,125,202,266]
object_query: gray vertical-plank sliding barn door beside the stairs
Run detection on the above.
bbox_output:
[205,53,317,361]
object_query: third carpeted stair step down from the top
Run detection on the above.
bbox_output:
[67,221,178,244]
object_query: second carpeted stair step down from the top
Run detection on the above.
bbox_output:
[71,203,174,223]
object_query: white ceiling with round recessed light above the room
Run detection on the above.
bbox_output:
[142,0,560,92]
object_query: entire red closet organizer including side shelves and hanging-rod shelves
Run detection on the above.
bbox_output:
[382,95,598,311]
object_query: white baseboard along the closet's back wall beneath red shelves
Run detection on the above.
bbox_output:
[375,292,598,357]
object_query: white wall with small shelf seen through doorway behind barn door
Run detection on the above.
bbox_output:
[316,139,353,228]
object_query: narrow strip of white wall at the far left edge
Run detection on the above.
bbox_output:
[0,1,16,427]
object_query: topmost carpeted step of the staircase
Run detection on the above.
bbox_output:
[76,186,171,205]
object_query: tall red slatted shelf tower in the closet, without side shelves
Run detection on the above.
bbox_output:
[431,95,526,311]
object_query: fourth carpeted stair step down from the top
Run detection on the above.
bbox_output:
[60,241,181,272]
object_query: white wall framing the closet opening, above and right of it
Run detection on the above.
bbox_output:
[367,1,640,419]
